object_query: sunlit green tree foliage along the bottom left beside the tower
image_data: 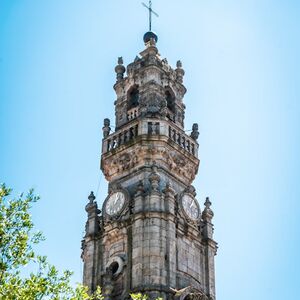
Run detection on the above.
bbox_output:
[0,184,159,300]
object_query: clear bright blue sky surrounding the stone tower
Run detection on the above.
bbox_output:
[0,0,300,300]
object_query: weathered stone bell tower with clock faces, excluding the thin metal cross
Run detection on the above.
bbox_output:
[82,31,217,300]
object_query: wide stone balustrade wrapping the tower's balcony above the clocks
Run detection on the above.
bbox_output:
[102,118,198,157]
